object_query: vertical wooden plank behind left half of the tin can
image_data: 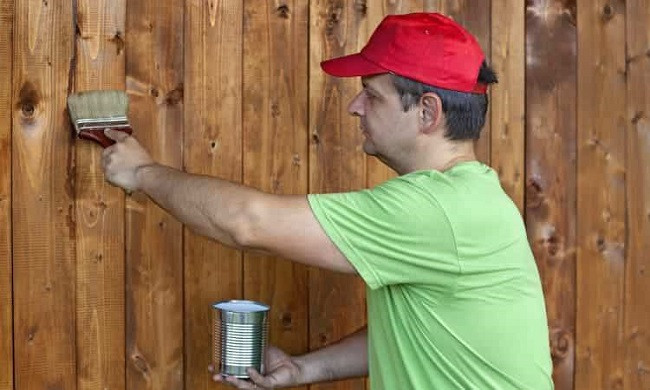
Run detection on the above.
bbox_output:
[184,0,243,390]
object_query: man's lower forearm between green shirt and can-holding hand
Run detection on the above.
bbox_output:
[296,329,368,383]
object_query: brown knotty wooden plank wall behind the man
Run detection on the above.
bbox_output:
[0,0,650,390]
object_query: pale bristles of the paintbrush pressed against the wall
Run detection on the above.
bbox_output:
[68,91,129,124]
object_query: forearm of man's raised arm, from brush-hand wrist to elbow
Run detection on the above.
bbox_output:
[137,164,260,247]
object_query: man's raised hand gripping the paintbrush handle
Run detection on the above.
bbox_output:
[102,129,155,191]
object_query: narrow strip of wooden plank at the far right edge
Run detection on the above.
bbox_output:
[623,0,650,389]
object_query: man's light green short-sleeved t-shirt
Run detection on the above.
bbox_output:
[309,161,553,390]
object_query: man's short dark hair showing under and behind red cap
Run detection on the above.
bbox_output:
[391,61,497,140]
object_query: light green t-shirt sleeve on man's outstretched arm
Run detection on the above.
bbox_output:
[308,177,460,289]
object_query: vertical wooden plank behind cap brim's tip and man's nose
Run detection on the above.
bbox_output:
[309,0,367,390]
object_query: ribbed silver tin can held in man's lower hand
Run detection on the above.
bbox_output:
[212,300,270,378]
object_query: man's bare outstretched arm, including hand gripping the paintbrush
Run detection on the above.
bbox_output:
[102,130,356,273]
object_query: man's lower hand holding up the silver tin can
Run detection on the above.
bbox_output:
[208,346,305,389]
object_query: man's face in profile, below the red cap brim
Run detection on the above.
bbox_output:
[348,74,419,166]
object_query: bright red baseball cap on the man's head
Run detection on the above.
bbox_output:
[321,12,487,94]
